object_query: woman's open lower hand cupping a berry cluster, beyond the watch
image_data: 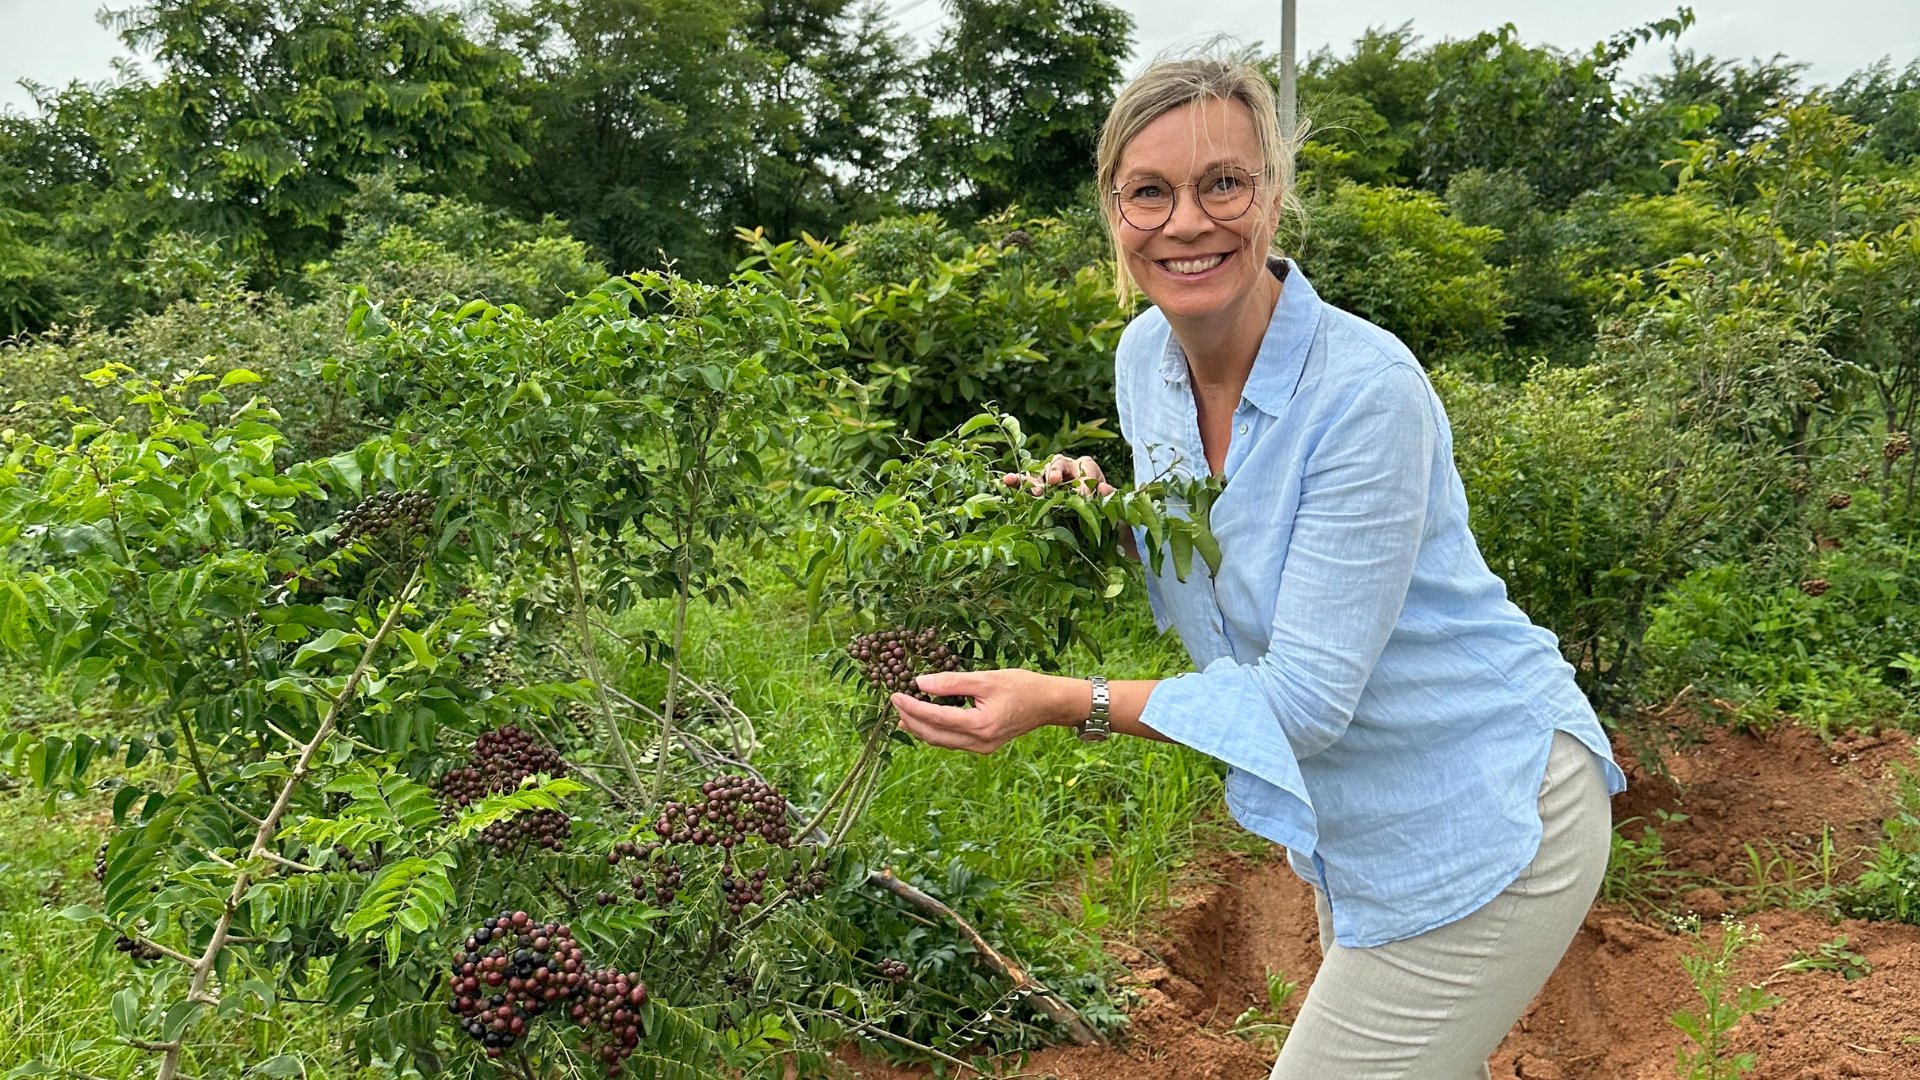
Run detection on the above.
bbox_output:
[891,667,1092,753]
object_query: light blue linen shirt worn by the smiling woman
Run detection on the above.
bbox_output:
[1116,259,1626,947]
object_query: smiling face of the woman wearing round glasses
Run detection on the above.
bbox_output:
[1108,98,1277,319]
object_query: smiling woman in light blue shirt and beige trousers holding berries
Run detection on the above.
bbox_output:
[893,48,1624,1080]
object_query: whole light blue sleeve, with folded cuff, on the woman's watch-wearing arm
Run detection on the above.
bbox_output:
[1140,363,1438,851]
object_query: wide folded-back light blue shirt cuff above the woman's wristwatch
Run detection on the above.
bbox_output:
[1140,645,1319,851]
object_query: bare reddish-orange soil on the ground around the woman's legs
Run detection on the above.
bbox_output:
[847,728,1920,1080]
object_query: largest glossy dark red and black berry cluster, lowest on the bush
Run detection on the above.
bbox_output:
[447,911,588,1057]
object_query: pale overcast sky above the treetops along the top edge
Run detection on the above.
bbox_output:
[0,0,1920,110]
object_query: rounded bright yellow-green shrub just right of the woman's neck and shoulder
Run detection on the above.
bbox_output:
[1284,183,1511,361]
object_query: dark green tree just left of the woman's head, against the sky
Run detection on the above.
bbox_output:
[908,0,1133,215]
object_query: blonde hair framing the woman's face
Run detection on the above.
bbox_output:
[1094,55,1306,306]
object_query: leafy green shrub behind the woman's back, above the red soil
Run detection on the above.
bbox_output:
[1436,344,1776,713]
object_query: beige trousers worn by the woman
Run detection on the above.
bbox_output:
[1269,732,1613,1080]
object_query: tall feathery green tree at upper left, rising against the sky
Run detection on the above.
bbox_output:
[109,0,526,271]
